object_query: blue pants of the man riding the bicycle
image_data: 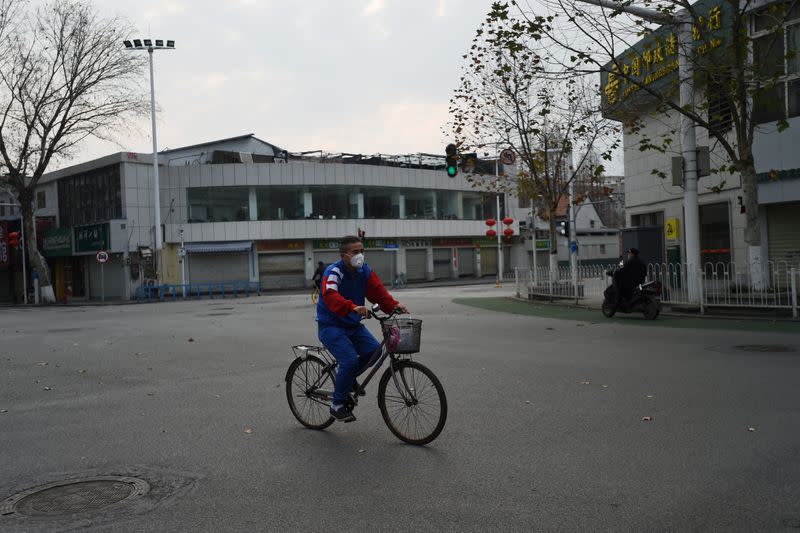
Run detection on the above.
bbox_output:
[318,324,380,404]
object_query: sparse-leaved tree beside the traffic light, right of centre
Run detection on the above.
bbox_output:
[449,8,619,272]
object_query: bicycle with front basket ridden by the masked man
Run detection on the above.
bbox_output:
[285,305,447,446]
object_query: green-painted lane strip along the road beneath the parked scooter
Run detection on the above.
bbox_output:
[453,296,800,333]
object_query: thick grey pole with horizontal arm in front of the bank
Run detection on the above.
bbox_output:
[580,0,700,302]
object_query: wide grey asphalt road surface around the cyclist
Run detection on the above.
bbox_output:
[0,287,800,532]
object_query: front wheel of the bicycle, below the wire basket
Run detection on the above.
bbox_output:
[378,361,447,445]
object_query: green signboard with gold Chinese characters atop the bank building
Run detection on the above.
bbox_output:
[600,0,732,118]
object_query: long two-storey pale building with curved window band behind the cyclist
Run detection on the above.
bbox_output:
[34,135,519,299]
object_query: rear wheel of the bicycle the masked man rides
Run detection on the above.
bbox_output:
[286,356,336,429]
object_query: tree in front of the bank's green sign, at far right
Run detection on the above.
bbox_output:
[510,0,798,284]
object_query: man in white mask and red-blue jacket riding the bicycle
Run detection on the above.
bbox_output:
[317,236,408,422]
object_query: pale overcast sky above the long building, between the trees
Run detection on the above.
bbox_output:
[75,0,624,172]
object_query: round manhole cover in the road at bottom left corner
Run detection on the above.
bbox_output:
[0,476,150,517]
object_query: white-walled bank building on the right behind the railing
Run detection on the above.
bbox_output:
[604,1,800,269]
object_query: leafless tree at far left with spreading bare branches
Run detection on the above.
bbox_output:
[0,0,148,301]
